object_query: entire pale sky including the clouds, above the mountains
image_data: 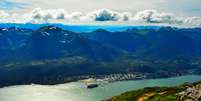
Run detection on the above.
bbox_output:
[0,0,201,26]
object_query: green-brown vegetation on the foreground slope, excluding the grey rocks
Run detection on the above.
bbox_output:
[107,82,201,101]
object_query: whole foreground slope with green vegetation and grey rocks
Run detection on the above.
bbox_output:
[106,82,201,101]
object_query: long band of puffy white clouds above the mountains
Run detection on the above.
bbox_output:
[0,8,201,26]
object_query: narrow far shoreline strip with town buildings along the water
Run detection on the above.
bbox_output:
[0,73,201,88]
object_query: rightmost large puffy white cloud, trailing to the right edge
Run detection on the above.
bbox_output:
[133,10,201,26]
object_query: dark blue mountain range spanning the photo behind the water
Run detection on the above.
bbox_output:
[0,26,201,85]
